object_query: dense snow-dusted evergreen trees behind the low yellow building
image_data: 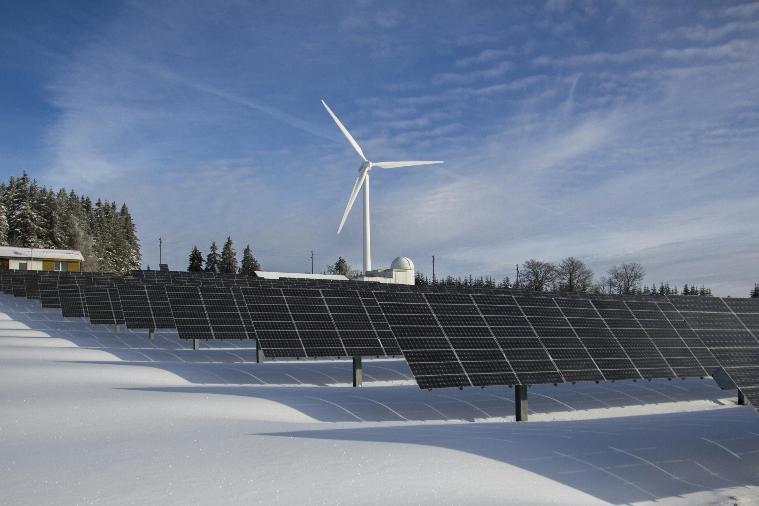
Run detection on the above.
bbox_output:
[0,172,141,273]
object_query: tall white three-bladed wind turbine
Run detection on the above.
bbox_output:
[322,100,443,274]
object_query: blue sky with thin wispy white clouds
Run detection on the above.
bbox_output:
[0,0,759,296]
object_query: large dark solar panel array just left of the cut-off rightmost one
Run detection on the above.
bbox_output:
[375,293,732,388]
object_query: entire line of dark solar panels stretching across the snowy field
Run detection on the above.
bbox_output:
[0,273,759,414]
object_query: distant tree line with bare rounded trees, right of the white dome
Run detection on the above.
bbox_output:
[416,257,716,296]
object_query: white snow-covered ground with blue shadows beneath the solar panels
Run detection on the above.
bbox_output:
[0,295,759,505]
